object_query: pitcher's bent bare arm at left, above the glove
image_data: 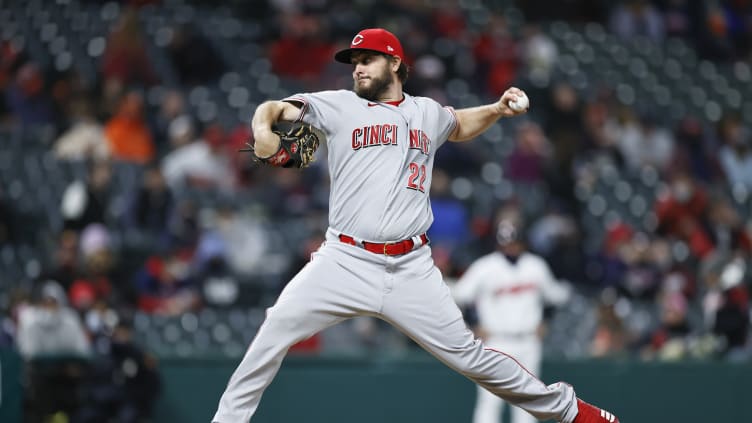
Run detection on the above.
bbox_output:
[251,100,300,157]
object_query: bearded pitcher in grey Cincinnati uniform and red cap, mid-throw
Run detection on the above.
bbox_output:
[213,28,618,423]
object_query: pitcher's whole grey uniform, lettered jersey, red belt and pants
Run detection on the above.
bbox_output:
[213,90,577,423]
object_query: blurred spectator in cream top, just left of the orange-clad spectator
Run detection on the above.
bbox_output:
[54,98,110,161]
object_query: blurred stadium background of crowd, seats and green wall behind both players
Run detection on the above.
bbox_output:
[0,0,752,423]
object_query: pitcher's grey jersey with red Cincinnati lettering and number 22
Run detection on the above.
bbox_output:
[285,90,457,242]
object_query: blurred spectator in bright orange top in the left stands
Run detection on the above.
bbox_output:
[104,91,155,164]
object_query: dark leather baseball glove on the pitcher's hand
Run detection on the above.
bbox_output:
[240,122,325,168]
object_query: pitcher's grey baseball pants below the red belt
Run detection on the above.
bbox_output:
[212,229,577,423]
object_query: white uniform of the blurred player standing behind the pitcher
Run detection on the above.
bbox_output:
[452,251,570,423]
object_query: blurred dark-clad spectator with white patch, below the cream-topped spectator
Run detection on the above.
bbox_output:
[61,162,112,231]
